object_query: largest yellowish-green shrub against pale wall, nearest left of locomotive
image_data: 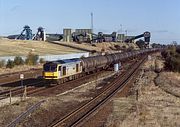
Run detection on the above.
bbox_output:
[25,53,39,65]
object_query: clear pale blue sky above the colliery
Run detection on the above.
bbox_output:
[0,0,180,44]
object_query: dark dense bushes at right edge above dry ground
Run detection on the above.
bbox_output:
[161,46,180,72]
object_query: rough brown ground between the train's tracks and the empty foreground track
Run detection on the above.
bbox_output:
[0,73,114,127]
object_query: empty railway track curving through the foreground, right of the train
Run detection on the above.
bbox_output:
[50,56,147,127]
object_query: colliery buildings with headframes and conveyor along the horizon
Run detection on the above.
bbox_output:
[8,25,150,43]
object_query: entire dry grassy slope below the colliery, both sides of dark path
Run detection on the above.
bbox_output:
[0,38,137,56]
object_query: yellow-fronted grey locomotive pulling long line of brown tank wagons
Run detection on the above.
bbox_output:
[43,48,162,84]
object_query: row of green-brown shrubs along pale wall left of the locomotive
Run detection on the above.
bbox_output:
[0,52,45,68]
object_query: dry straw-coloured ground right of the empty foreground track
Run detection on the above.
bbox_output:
[104,53,180,127]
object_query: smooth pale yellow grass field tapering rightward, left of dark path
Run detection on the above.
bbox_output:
[0,39,82,56]
